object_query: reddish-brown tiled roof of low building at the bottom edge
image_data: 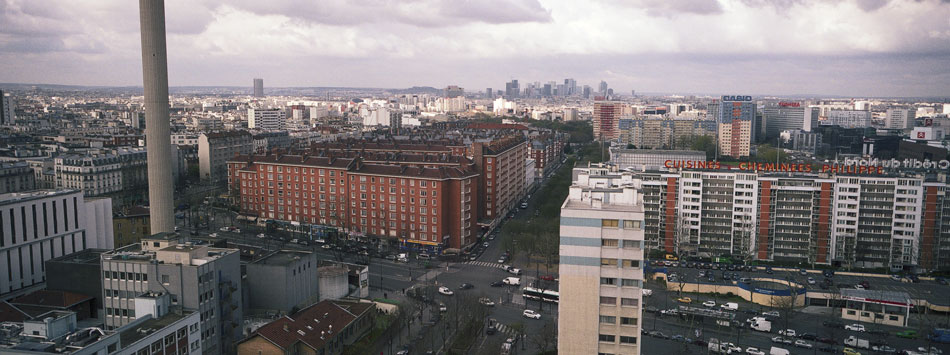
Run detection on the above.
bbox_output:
[255,301,375,350]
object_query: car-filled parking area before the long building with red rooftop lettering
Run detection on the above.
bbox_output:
[642,265,950,354]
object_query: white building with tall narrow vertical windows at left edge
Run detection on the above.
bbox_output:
[0,190,113,298]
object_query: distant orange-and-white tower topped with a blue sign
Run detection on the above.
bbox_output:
[709,96,756,158]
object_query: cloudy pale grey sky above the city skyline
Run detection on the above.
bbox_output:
[0,0,950,96]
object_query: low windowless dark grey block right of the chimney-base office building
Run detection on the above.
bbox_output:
[247,250,320,313]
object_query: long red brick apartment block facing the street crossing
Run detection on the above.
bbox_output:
[228,155,479,252]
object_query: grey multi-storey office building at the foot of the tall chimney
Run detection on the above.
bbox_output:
[101,233,244,354]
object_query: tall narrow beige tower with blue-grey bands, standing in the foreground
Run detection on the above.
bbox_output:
[557,167,644,354]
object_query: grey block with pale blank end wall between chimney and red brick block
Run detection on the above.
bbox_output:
[198,131,254,180]
